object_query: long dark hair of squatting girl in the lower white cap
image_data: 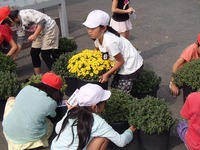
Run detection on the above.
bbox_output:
[57,107,94,150]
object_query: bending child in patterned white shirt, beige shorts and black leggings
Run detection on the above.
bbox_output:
[9,9,59,75]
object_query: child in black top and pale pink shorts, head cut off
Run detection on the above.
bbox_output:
[110,0,135,39]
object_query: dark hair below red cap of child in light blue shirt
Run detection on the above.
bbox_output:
[30,82,63,102]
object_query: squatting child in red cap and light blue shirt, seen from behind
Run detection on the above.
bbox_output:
[2,72,63,150]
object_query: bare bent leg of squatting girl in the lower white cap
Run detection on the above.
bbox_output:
[87,137,109,150]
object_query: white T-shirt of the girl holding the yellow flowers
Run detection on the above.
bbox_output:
[94,31,143,75]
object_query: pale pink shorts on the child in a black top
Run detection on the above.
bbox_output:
[110,18,132,33]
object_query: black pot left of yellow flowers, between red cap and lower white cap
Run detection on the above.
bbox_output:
[65,77,78,97]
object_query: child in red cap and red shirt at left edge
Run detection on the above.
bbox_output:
[0,6,18,60]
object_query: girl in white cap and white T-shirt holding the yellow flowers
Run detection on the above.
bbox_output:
[83,10,143,93]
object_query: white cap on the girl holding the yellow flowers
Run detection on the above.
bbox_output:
[83,10,110,28]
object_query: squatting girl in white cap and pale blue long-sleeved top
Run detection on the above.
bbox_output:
[51,83,136,150]
